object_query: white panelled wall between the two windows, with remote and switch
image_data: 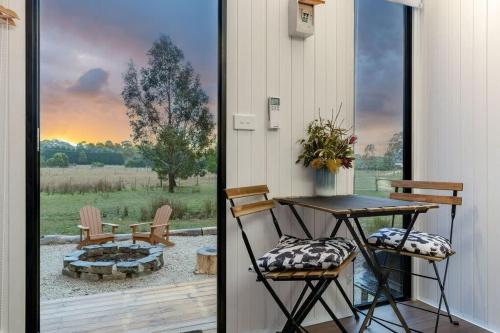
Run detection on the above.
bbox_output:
[226,0,354,333]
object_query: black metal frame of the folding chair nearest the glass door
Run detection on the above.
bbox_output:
[229,194,359,333]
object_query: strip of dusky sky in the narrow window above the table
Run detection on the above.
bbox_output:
[355,0,404,155]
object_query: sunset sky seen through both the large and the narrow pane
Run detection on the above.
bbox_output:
[40,0,403,154]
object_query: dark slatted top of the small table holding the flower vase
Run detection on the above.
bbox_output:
[274,195,438,215]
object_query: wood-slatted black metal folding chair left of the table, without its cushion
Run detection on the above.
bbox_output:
[225,185,359,333]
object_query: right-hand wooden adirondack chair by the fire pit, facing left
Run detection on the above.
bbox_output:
[130,205,175,246]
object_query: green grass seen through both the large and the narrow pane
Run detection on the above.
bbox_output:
[40,167,401,235]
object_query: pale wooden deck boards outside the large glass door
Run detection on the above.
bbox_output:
[40,279,217,333]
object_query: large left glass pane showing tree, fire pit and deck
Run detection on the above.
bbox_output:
[40,0,218,332]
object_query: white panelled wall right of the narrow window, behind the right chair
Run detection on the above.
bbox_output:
[413,0,500,331]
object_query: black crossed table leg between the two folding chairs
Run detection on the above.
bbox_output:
[343,217,410,333]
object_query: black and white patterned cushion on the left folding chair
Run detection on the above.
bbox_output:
[257,236,356,272]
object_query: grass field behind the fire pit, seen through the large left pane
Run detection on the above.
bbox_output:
[40,167,217,235]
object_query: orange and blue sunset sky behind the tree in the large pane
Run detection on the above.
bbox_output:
[40,0,218,143]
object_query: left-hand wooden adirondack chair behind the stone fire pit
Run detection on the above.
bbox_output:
[78,206,118,249]
